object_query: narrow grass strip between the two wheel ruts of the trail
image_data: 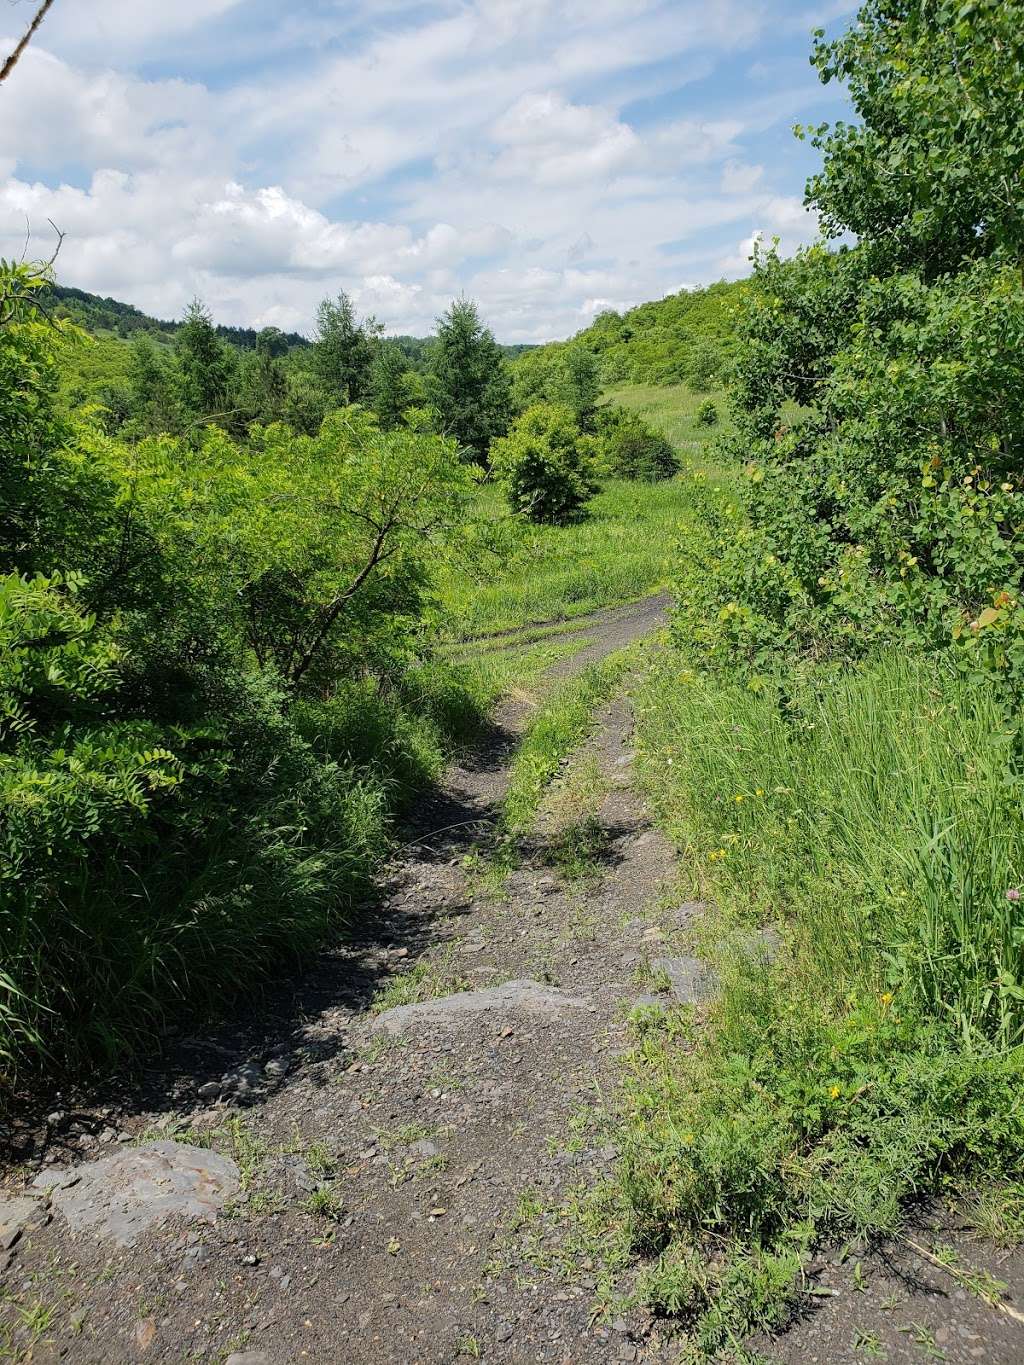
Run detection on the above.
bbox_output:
[504,646,636,834]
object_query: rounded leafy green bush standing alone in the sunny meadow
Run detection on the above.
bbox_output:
[490,404,598,526]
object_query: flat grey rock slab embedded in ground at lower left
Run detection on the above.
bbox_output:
[40,1141,242,1246]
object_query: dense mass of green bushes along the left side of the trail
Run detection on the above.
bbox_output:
[0,257,483,1078]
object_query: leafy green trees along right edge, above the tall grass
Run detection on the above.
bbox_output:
[688,4,1024,699]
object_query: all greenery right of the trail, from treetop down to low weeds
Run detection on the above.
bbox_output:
[590,0,1024,1358]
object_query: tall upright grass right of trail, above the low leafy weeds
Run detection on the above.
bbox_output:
[642,655,1024,1046]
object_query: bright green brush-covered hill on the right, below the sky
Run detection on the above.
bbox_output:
[517,280,748,388]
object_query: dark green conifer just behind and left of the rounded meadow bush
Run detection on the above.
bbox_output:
[429,299,512,460]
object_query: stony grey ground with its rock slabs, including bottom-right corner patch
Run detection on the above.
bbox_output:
[0,601,1024,1365]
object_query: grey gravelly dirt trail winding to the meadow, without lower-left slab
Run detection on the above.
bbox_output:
[5,601,693,1365]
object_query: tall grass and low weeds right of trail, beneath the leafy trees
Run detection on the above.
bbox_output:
[584,652,1024,1360]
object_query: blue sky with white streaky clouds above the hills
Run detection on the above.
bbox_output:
[0,0,855,341]
